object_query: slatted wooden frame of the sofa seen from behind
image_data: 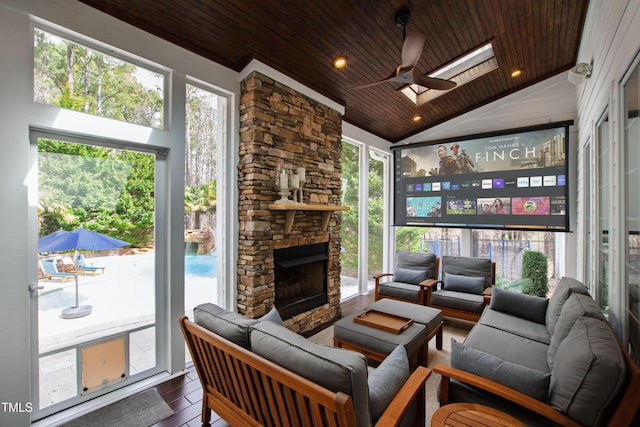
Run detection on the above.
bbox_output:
[180,316,431,427]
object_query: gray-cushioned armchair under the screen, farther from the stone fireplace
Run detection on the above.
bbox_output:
[426,256,496,322]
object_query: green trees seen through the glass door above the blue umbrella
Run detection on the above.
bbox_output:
[38,139,155,246]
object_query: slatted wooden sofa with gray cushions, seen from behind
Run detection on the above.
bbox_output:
[180,304,431,427]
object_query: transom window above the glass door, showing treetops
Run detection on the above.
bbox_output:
[33,28,164,129]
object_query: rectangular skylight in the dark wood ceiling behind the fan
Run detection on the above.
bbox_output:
[402,42,498,105]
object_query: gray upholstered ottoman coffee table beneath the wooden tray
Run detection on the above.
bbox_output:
[333,298,443,366]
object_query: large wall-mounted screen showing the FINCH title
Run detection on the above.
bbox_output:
[392,122,573,232]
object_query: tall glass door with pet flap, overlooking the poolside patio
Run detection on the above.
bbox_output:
[31,133,166,419]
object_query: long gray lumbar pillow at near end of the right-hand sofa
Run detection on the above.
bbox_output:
[451,338,551,402]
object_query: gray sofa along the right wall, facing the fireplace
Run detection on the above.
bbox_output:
[434,277,640,426]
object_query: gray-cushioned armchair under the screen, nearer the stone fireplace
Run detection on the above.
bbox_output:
[373,251,440,305]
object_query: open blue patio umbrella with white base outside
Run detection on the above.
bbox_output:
[38,227,129,319]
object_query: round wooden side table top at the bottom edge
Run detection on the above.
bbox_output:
[431,403,526,427]
